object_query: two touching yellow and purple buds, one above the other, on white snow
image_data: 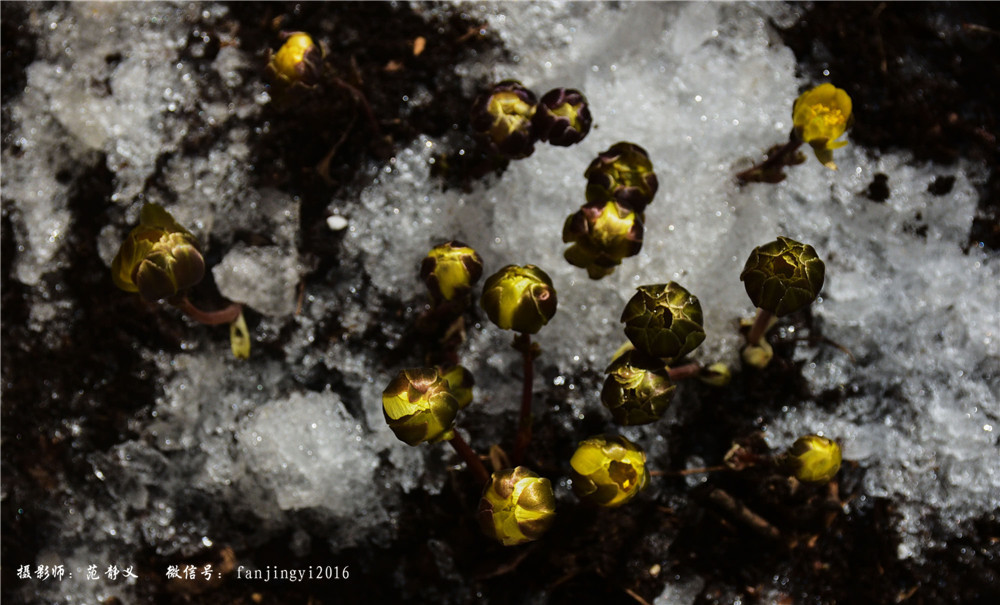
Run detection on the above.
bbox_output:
[563,142,658,279]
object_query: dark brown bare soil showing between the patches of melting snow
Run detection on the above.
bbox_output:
[0,2,1000,604]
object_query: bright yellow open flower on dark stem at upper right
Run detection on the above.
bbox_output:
[792,83,852,170]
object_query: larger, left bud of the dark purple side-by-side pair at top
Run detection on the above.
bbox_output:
[470,80,538,159]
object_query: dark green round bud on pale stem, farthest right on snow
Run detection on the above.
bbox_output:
[740,237,826,317]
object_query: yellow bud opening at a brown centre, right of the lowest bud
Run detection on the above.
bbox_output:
[569,435,649,507]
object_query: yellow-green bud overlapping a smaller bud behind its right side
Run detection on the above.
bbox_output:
[382,368,459,445]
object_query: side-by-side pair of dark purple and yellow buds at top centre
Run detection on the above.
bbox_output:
[470,80,593,159]
